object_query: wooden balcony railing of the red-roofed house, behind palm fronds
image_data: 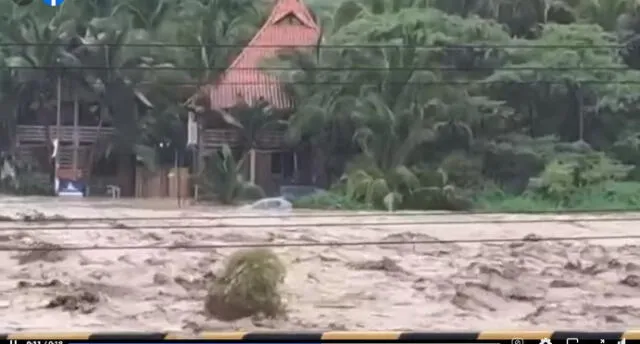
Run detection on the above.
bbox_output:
[201,129,285,150]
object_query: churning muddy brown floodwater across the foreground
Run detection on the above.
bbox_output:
[0,198,640,332]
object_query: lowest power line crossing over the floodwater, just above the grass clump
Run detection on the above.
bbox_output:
[5,235,640,252]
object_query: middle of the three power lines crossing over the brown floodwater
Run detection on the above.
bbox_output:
[5,216,640,232]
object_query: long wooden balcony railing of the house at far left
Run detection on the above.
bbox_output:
[16,125,113,144]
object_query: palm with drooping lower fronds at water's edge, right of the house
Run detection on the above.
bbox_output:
[344,97,435,210]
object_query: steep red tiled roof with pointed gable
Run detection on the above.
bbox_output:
[209,0,320,109]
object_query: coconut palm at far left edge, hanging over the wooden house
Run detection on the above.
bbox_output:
[0,11,93,167]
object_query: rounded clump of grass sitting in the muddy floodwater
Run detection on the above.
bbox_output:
[205,248,286,321]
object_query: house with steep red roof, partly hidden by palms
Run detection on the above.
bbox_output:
[192,0,321,194]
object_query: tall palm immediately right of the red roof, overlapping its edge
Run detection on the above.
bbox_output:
[265,0,426,186]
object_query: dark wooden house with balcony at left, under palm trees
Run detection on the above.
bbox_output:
[15,78,151,196]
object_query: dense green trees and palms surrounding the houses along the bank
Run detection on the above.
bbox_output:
[0,0,640,210]
